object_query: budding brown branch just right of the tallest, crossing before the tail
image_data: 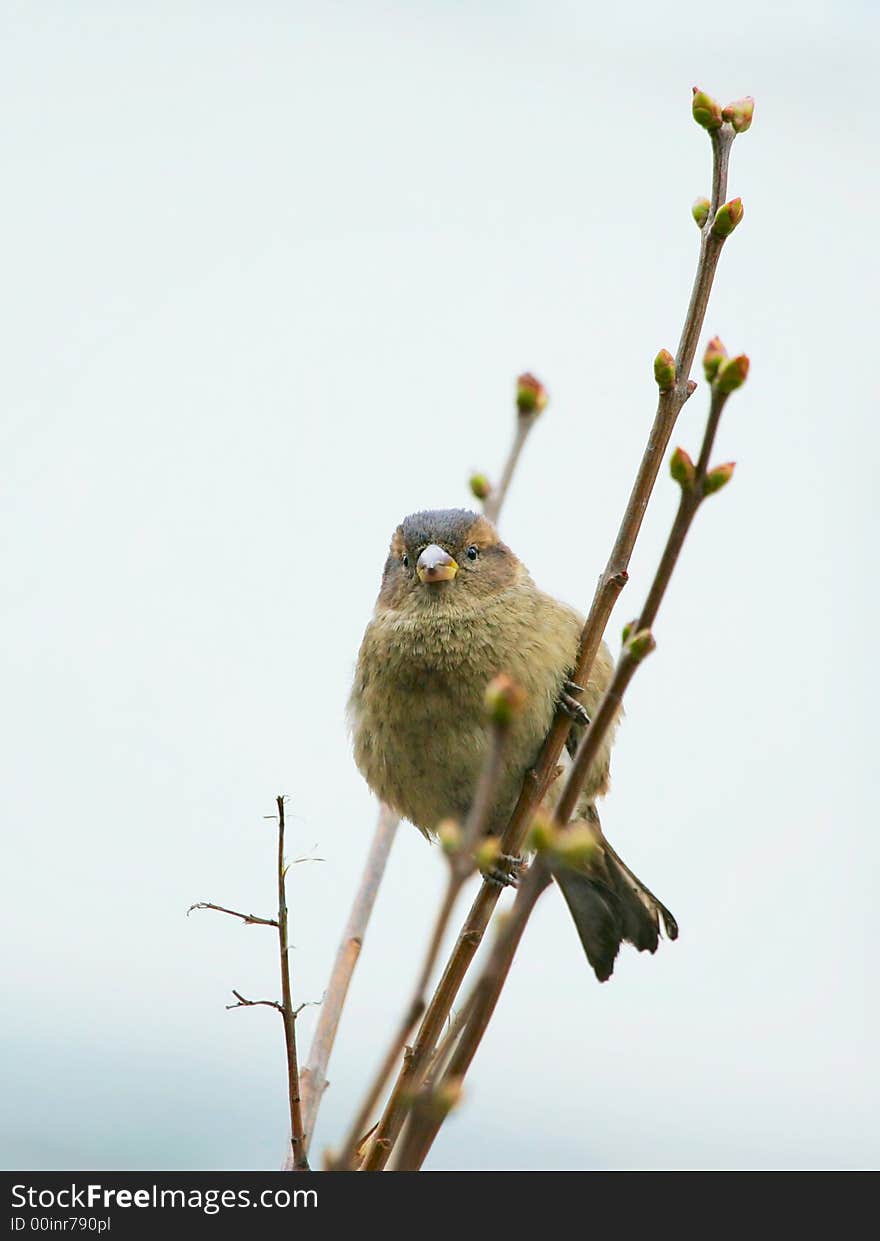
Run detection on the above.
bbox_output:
[397,362,730,1172]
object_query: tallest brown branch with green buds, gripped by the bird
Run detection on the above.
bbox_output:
[362,124,735,1170]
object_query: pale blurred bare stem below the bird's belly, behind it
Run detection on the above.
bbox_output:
[299,805,400,1152]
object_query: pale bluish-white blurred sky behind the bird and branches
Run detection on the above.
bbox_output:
[0,0,880,1169]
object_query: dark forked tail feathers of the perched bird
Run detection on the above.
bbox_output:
[552,807,679,983]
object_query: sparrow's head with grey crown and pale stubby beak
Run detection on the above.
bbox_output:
[379,509,525,612]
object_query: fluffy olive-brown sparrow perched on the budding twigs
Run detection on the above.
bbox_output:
[348,509,678,982]
